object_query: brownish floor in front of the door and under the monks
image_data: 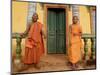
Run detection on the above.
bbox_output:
[12,54,95,73]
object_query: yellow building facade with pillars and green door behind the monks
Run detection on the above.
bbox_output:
[12,1,96,55]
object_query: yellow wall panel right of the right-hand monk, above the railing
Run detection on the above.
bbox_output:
[79,6,91,33]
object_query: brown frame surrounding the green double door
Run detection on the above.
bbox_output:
[44,4,69,54]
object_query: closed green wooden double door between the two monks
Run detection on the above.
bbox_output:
[47,8,66,53]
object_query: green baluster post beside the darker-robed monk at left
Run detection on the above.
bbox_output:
[15,33,22,63]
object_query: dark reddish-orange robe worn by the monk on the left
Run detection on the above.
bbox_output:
[24,22,44,64]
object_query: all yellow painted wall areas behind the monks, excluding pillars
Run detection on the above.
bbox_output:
[12,1,91,56]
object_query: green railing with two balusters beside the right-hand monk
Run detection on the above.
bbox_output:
[82,34,96,60]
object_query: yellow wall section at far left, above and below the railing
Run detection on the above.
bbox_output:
[12,1,28,55]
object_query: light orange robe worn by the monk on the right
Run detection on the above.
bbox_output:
[69,24,82,64]
